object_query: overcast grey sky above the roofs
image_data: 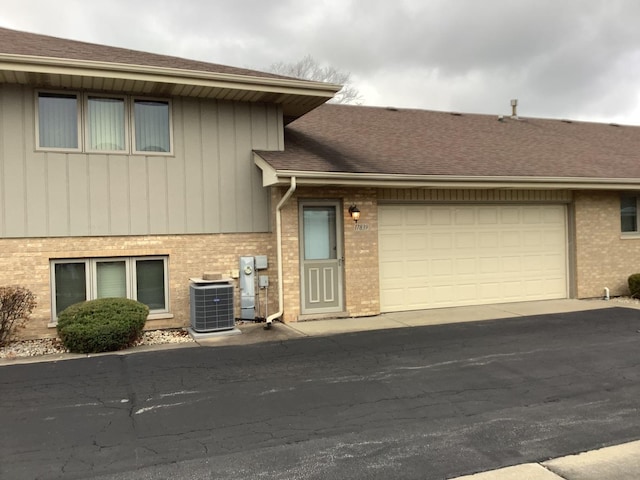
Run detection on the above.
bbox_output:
[0,0,640,125]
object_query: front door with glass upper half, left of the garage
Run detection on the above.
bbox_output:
[300,200,344,314]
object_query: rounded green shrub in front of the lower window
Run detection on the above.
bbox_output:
[58,298,149,353]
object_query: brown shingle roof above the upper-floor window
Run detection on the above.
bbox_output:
[0,28,286,78]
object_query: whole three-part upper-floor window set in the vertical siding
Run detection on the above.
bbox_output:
[37,92,172,154]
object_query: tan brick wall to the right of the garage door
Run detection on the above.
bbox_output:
[574,192,640,298]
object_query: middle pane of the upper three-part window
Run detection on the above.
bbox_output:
[88,97,126,151]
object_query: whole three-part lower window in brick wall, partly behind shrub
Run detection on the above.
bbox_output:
[51,257,169,318]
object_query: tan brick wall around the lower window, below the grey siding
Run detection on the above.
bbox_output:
[0,233,277,338]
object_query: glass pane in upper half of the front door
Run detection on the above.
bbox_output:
[303,207,338,260]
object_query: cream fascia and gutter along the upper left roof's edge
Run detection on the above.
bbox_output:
[0,54,342,98]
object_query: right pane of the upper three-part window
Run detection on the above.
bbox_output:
[134,100,171,152]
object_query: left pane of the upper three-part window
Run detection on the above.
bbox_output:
[38,93,78,148]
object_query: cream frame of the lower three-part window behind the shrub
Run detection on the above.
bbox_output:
[49,255,170,324]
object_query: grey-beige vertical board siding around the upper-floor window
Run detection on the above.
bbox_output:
[0,85,276,238]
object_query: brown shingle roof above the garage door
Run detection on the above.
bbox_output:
[258,104,640,179]
